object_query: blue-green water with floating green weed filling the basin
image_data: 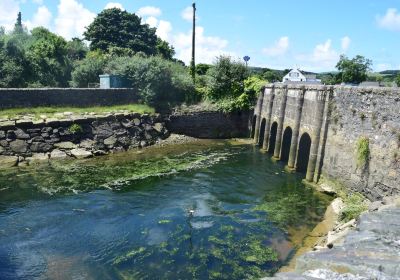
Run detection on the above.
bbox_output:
[0,141,329,279]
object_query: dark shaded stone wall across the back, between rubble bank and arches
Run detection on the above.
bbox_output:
[167,111,252,139]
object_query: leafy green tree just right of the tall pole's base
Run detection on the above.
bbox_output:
[208,56,248,100]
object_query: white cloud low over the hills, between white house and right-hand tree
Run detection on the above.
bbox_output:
[295,39,340,71]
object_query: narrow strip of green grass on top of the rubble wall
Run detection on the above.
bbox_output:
[0,104,155,119]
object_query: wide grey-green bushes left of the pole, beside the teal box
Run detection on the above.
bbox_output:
[106,55,195,106]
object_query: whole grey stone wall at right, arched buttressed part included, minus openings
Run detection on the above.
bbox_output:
[253,84,400,200]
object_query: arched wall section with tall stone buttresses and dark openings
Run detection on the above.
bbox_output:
[252,84,332,182]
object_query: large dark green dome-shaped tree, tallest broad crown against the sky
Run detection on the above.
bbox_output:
[84,8,157,55]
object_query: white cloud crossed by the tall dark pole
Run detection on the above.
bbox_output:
[172,26,236,64]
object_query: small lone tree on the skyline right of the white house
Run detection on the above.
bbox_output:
[336,55,372,84]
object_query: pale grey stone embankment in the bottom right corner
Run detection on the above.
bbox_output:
[265,198,400,280]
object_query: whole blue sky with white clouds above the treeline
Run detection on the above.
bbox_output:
[0,0,400,72]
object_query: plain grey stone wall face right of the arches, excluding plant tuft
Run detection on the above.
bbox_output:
[322,87,400,199]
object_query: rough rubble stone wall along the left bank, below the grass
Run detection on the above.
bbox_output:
[0,113,169,167]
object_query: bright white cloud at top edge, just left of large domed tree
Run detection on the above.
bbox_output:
[55,0,96,39]
